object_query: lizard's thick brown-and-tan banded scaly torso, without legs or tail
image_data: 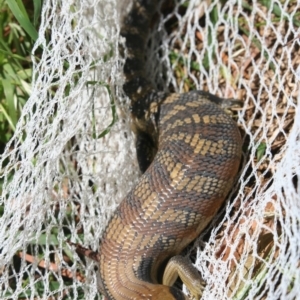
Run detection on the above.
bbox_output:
[99,91,241,300]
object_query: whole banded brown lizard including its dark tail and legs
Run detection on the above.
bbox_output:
[71,0,241,300]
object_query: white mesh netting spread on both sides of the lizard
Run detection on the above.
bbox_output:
[0,0,300,299]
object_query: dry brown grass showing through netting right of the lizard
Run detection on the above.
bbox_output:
[165,1,300,299]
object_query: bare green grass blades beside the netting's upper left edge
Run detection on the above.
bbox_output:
[0,0,41,154]
